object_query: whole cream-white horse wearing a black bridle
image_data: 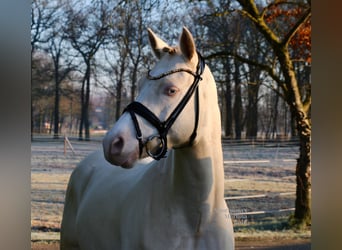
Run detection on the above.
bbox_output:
[61,28,234,250]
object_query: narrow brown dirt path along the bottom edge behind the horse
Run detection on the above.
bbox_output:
[31,240,311,250]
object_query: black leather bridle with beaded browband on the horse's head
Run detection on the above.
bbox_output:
[123,51,205,160]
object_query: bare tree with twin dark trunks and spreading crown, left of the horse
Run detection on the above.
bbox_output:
[64,0,115,140]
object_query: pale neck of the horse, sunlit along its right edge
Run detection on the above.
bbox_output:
[170,75,224,211]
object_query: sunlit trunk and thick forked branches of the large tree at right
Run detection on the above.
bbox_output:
[238,0,311,226]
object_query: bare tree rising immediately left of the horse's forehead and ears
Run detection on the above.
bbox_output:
[103,0,154,120]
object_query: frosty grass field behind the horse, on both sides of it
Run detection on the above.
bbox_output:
[31,138,311,242]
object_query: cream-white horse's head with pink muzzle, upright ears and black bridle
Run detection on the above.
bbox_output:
[103,27,205,168]
